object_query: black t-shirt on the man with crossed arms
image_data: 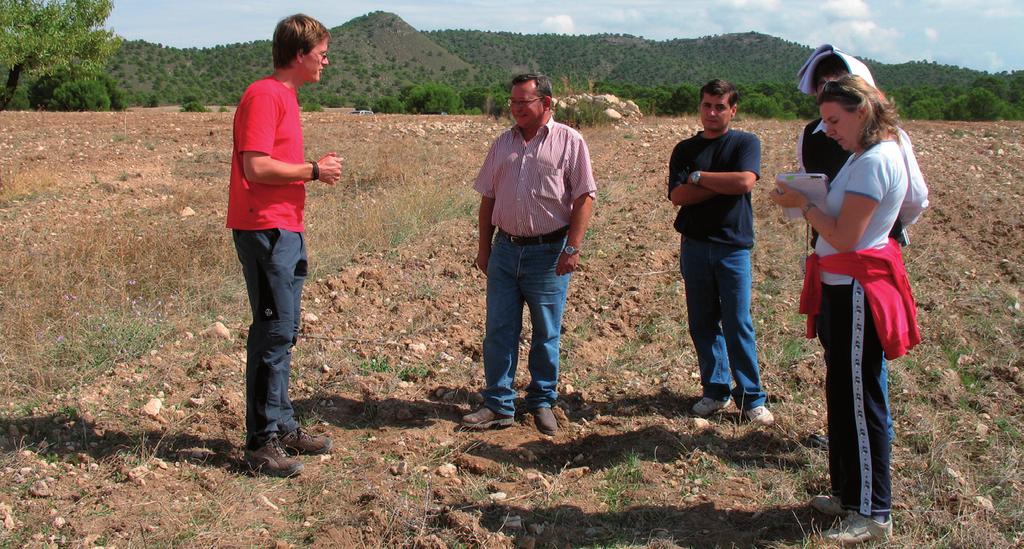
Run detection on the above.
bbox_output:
[669,130,761,248]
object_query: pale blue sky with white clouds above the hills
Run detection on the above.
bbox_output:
[106,0,1024,73]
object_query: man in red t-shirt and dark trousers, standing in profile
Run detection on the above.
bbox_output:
[227,13,341,476]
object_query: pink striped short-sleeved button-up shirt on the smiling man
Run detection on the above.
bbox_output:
[473,120,597,237]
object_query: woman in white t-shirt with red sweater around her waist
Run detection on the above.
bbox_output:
[771,75,921,544]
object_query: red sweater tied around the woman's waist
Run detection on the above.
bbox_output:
[800,239,921,360]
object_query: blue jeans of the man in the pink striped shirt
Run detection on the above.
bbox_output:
[482,233,571,415]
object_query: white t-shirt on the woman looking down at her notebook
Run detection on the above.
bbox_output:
[814,140,907,285]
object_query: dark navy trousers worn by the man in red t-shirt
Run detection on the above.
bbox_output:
[232,228,307,450]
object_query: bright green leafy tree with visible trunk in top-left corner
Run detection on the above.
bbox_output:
[0,0,121,111]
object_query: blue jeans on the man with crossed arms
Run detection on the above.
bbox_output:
[679,239,767,410]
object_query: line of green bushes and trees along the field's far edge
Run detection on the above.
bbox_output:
[9,72,1024,121]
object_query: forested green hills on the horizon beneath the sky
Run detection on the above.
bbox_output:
[109,11,1003,104]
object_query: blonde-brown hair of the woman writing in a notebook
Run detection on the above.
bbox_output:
[818,75,899,149]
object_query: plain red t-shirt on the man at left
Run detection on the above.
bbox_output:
[227,77,306,233]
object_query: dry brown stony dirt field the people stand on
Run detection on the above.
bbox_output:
[0,112,1024,548]
